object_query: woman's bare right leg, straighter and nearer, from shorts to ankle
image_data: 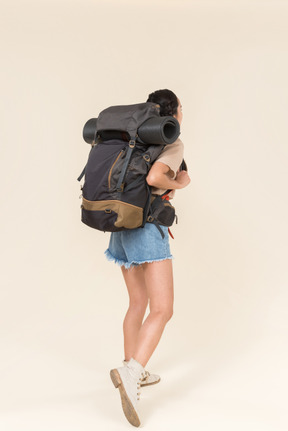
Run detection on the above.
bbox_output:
[133,259,174,367]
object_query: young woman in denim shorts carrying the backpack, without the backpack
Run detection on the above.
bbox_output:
[105,90,190,426]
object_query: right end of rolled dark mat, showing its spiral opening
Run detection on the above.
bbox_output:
[138,116,180,145]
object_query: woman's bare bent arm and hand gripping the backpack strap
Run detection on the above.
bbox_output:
[146,162,191,190]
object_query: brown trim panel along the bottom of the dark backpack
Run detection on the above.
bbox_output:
[82,198,143,229]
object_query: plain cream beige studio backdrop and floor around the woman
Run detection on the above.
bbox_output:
[0,0,288,431]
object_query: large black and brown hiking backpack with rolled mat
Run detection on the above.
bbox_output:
[78,102,180,236]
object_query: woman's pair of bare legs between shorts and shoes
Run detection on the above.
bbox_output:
[122,259,174,367]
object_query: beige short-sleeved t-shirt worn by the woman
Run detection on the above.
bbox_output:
[152,138,184,198]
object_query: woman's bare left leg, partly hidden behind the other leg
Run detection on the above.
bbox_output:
[121,265,148,361]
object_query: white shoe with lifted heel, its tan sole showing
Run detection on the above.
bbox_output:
[110,358,145,427]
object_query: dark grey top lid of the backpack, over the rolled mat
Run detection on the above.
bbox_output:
[97,102,160,139]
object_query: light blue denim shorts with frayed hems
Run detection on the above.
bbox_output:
[105,223,173,268]
